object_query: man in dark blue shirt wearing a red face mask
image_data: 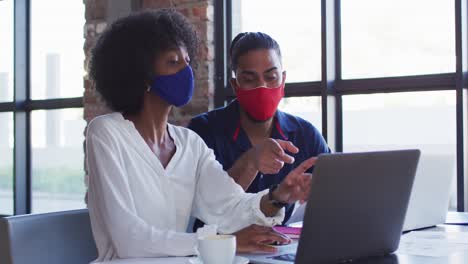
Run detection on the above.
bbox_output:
[189,32,330,230]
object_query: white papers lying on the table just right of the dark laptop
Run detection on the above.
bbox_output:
[397,231,468,257]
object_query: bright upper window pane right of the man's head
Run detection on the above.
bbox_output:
[341,0,455,79]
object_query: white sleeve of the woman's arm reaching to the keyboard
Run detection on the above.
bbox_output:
[86,133,197,258]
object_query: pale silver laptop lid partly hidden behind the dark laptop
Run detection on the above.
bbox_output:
[403,154,455,231]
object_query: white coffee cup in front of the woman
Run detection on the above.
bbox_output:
[198,235,236,264]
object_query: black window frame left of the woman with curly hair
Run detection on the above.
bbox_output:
[0,0,84,217]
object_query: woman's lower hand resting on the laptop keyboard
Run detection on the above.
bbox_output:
[234,225,291,253]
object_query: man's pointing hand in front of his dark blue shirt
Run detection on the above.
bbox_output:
[251,138,299,174]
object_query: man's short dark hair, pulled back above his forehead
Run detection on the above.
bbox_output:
[230,32,281,71]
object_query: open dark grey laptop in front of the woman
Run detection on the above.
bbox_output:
[242,150,420,264]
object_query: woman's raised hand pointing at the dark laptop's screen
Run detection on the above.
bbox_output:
[273,157,317,203]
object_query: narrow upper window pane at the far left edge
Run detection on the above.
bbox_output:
[0,0,14,102]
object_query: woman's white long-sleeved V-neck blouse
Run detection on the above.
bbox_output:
[86,113,284,262]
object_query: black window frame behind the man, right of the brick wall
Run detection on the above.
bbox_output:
[214,0,468,212]
